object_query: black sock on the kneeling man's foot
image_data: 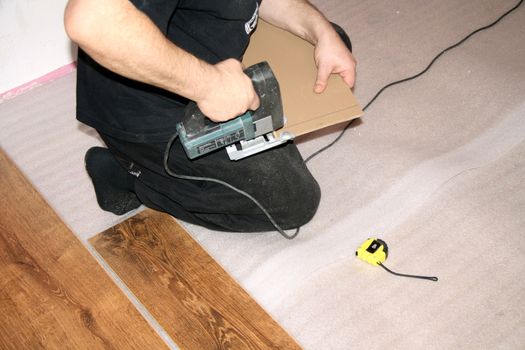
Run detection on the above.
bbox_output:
[85,147,141,215]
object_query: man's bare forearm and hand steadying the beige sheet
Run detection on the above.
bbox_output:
[260,0,356,93]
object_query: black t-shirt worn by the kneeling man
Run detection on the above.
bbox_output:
[77,0,261,142]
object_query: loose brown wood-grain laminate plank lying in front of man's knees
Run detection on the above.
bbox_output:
[90,210,299,350]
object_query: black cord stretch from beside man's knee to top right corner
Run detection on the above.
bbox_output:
[304,0,523,163]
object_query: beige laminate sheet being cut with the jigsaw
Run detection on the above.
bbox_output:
[243,20,363,136]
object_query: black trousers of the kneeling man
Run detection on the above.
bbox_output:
[101,134,321,232]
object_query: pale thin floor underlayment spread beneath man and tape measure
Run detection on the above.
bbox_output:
[0,0,525,349]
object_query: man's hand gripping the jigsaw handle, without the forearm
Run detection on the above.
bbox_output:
[196,59,260,122]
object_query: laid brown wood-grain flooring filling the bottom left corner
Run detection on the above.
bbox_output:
[0,150,167,349]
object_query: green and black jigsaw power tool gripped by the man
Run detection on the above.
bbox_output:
[177,62,293,160]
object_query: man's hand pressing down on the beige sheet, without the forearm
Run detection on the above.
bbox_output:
[314,28,357,93]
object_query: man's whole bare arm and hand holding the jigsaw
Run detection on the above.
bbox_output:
[64,0,259,121]
